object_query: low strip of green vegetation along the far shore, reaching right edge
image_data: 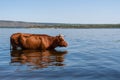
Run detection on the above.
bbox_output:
[29,24,120,28]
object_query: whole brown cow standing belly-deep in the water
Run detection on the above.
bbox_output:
[10,33,68,50]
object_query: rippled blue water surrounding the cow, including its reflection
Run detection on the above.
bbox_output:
[0,28,120,80]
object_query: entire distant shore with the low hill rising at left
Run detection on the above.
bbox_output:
[0,20,120,28]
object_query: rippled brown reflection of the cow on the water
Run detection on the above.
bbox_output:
[11,50,67,69]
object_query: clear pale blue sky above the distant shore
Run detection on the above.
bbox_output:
[0,0,120,24]
